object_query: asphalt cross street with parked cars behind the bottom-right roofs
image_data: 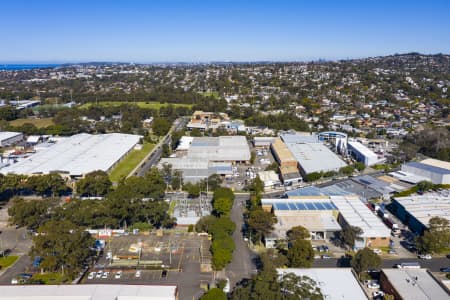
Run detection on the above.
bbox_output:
[313,257,450,272]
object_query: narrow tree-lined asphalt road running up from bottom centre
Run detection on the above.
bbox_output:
[225,195,257,287]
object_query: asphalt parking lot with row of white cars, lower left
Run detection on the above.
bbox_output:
[82,232,213,299]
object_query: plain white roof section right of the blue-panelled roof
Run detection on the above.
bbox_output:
[330,196,391,238]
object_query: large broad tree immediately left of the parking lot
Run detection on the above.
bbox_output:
[30,220,94,277]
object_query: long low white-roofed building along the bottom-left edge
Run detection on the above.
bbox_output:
[0,284,178,300]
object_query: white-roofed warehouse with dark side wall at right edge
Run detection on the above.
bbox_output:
[392,190,450,234]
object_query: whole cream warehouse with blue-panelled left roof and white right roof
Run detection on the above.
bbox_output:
[261,195,391,249]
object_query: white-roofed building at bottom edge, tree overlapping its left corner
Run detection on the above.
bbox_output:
[277,268,367,300]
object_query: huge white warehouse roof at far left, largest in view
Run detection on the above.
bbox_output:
[0,133,141,176]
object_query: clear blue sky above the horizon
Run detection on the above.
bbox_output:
[0,0,450,63]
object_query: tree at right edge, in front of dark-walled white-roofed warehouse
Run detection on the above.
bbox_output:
[417,217,450,253]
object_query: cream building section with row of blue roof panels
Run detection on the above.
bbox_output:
[261,197,341,248]
